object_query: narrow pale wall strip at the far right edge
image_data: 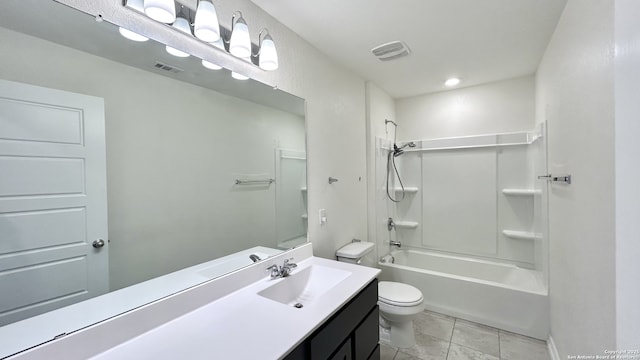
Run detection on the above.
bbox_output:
[615,0,640,349]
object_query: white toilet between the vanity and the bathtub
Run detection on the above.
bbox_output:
[336,241,424,348]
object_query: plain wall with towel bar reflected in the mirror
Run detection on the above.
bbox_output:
[0,28,305,290]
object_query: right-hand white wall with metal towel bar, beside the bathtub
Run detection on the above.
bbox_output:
[536,0,620,359]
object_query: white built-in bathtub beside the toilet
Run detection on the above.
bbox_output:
[379,250,549,340]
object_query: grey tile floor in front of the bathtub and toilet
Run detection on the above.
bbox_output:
[380,311,550,360]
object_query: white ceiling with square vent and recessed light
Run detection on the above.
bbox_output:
[251,0,566,98]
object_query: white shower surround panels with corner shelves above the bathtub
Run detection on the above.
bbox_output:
[376,125,546,270]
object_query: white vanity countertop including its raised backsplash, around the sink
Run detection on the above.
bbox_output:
[5,243,379,359]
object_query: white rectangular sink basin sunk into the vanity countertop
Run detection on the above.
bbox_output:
[258,265,351,307]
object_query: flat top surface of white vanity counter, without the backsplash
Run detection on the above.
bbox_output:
[94,257,379,360]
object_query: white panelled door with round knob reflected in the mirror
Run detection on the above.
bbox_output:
[0,80,109,326]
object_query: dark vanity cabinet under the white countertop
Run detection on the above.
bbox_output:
[284,279,380,360]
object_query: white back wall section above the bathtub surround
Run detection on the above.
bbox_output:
[396,76,535,141]
